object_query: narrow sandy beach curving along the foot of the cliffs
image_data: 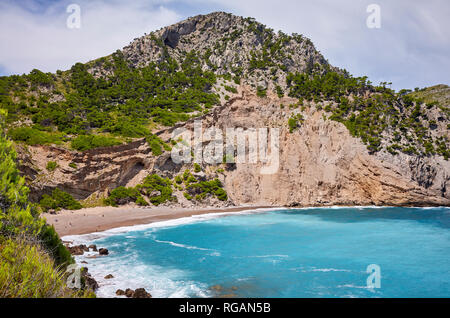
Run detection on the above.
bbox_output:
[42,206,272,236]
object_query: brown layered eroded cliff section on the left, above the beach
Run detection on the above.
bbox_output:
[18,140,151,200]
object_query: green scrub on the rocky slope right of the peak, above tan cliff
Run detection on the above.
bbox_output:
[287,70,450,159]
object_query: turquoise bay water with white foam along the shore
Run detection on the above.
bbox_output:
[72,208,450,297]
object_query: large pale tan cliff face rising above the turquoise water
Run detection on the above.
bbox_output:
[160,88,450,206]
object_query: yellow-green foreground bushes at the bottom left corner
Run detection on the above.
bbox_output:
[0,109,91,297]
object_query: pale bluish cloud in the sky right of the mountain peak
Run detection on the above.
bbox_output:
[192,0,450,89]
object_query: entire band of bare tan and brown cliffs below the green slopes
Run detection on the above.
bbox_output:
[17,87,450,206]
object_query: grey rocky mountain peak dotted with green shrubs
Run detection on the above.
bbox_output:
[122,12,331,89]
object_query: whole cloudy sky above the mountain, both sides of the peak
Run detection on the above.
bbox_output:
[0,0,450,90]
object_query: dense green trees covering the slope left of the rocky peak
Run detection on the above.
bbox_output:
[0,49,218,150]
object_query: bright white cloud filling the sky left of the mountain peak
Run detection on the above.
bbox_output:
[0,0,180,73]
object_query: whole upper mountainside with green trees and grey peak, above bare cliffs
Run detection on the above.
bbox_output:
[0,12,450,159]
